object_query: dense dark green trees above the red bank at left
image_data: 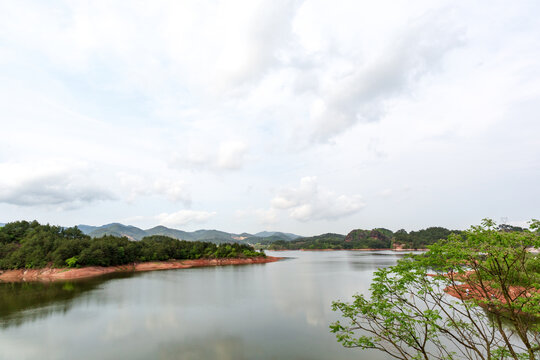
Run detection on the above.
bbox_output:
[0,221,265,269]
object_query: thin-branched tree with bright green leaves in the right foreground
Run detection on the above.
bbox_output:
[331,219,540,360]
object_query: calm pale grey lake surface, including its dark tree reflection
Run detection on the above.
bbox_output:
[0,251,410,360]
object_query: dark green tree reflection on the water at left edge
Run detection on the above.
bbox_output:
[0,274,131,328]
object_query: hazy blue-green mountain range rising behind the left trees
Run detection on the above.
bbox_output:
[77,223,300,243]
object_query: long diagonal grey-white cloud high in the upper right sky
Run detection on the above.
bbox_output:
[304,13,463,141]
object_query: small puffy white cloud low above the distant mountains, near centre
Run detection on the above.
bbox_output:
[271,177,365,221]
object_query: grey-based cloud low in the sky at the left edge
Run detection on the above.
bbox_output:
[0,162,114,209]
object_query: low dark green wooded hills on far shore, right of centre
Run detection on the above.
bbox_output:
[262,227,461,250]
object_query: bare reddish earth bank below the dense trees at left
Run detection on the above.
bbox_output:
[0,256,283,283]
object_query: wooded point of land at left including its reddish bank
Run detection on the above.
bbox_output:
[0,221,280,281]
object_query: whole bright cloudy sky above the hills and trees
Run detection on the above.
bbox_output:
[0,0,540,236]
